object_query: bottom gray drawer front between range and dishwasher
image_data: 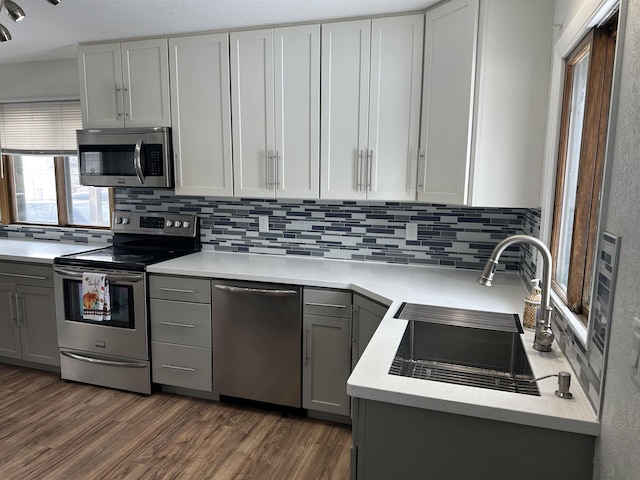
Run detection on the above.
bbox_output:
[151,342,213,392]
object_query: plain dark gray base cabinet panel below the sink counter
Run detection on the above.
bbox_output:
[351,399,595,480]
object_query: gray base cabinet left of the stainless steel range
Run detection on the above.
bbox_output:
[0,262,60,366]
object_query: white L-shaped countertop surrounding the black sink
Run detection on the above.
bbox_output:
[148,250,600,436]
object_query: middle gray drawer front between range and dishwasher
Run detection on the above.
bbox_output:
[149,298,211,348]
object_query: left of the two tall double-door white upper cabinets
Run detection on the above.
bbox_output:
[231,25,320,198]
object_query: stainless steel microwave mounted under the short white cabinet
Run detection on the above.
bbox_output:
[77,127,173,188]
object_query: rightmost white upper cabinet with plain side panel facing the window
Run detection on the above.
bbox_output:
[418,0,554,208]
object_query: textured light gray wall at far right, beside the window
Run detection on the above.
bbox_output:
[594,0,640,480]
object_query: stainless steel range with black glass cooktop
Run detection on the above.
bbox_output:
[53,211,202,394]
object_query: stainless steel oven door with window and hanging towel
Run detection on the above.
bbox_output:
[54,265,149,361]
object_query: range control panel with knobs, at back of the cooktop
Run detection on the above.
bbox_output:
[111,211,198,237]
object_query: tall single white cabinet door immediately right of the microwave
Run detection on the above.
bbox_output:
[169,33,233,197]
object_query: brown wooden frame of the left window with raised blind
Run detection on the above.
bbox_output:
[0,154,115,230]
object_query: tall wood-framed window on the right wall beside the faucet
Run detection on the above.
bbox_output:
[551,15,617,325]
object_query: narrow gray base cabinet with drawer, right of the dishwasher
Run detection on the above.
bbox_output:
[302,288,351,416]
